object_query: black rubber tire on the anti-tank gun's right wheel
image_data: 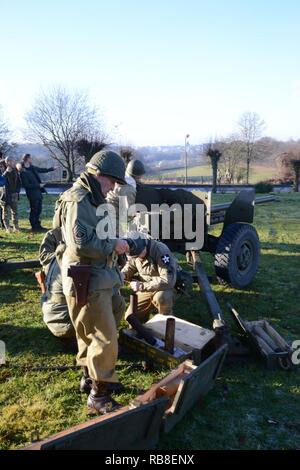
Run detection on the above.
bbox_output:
[214,223,260,289]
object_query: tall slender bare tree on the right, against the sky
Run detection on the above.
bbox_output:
[238,111,265,184]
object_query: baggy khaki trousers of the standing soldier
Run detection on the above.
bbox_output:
[66,289,124,382]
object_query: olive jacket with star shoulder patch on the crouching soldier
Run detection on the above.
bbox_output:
[122,240,177,292]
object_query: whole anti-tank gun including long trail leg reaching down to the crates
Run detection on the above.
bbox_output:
[136,185,274,354]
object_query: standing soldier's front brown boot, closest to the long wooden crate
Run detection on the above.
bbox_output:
[87,380,121,415]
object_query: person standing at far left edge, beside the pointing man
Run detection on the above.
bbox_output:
[0,157,21,232]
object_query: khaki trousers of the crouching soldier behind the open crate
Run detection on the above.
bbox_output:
[125,289,174,323]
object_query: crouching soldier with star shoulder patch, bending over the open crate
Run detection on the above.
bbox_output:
[122,238,177,322]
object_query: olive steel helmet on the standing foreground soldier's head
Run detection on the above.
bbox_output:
[85,150,126,184]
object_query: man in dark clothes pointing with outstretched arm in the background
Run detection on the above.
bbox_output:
[21,153,55,232]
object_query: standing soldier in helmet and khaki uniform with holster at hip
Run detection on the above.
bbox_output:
[53,150,129,414]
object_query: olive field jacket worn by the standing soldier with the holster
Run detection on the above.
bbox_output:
[53,173,122,296]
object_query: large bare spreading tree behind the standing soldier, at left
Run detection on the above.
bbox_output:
[25,86,106,181]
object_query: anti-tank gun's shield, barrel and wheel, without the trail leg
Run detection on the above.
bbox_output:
[136,185,274,288]
